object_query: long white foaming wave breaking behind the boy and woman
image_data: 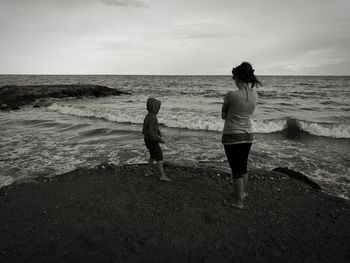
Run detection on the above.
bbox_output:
[49,103,350,138]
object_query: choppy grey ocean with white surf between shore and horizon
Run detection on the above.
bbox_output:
[0,75,350,199]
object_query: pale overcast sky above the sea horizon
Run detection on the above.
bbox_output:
[0,0,350,75]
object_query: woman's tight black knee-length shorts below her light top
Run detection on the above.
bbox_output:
[224,143,252,179]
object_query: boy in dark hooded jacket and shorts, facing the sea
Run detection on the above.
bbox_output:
[142,98,171,182]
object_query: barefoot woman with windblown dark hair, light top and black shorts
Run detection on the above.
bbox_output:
[222,62,261,209]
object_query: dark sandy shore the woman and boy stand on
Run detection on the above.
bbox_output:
[0,165,350,262]
